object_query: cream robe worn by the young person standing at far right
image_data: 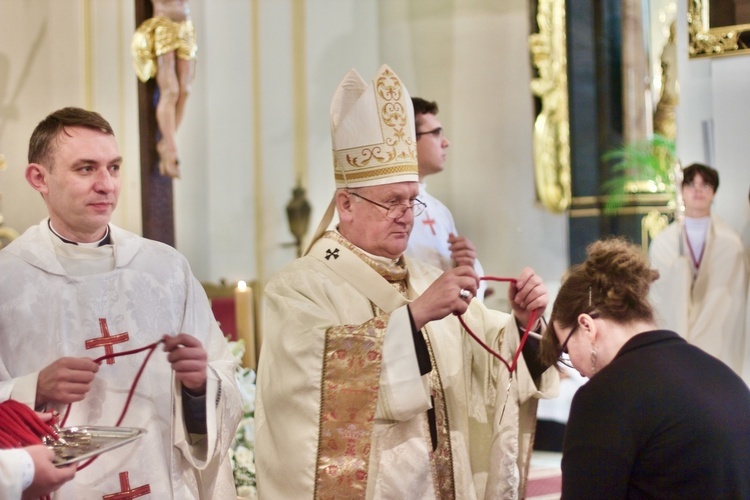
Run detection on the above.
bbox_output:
[649,215,750,382]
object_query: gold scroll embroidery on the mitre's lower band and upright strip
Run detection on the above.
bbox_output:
[333,67,418,188]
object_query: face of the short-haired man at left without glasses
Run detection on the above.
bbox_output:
[38,127,122,243]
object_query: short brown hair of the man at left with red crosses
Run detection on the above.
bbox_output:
[28,107,115,169]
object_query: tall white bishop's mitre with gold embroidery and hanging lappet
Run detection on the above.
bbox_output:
[310,64,419,254]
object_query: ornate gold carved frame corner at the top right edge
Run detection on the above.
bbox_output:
[687,0,750,57]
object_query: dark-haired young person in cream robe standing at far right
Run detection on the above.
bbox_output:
[649,163,750,382]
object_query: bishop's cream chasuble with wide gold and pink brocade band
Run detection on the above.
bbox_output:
[256,232,557,499]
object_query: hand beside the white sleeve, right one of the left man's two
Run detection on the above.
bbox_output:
[162,333,208,396]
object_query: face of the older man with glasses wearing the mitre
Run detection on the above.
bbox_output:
[339,182,419,259]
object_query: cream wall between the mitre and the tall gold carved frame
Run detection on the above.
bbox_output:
[381,0,568,300]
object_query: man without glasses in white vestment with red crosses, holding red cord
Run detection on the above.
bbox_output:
[0,108,242,500]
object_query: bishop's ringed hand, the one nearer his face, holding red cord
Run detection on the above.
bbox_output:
[409,266,479,329]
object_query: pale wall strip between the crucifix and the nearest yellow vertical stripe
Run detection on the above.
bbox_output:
[174,0,256,282]
